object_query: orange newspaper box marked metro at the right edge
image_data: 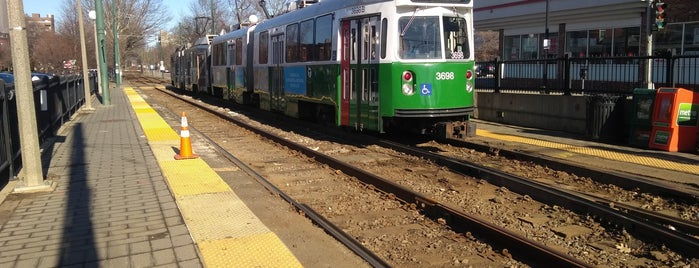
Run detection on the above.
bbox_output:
[648,87,699,152]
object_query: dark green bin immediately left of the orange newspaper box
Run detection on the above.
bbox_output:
[628,88,657,148]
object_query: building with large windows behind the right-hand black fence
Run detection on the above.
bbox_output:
[474,0,699,60]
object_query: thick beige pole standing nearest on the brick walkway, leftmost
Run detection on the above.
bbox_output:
[7,0,51,192]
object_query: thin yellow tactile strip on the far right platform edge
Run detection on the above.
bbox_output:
[476,129,699,175]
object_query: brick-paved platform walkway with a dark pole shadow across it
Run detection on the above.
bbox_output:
[0,85,202,267]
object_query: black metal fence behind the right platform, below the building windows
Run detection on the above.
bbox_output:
[476,55,699,95]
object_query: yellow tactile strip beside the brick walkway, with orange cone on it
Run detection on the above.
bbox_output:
[124,87,302,267]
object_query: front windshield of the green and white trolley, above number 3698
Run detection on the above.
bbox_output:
[398,16,471,60]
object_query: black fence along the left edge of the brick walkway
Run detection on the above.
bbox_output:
[0,74,97,188]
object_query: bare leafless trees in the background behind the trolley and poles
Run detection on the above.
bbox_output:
[0,0,499,74]
